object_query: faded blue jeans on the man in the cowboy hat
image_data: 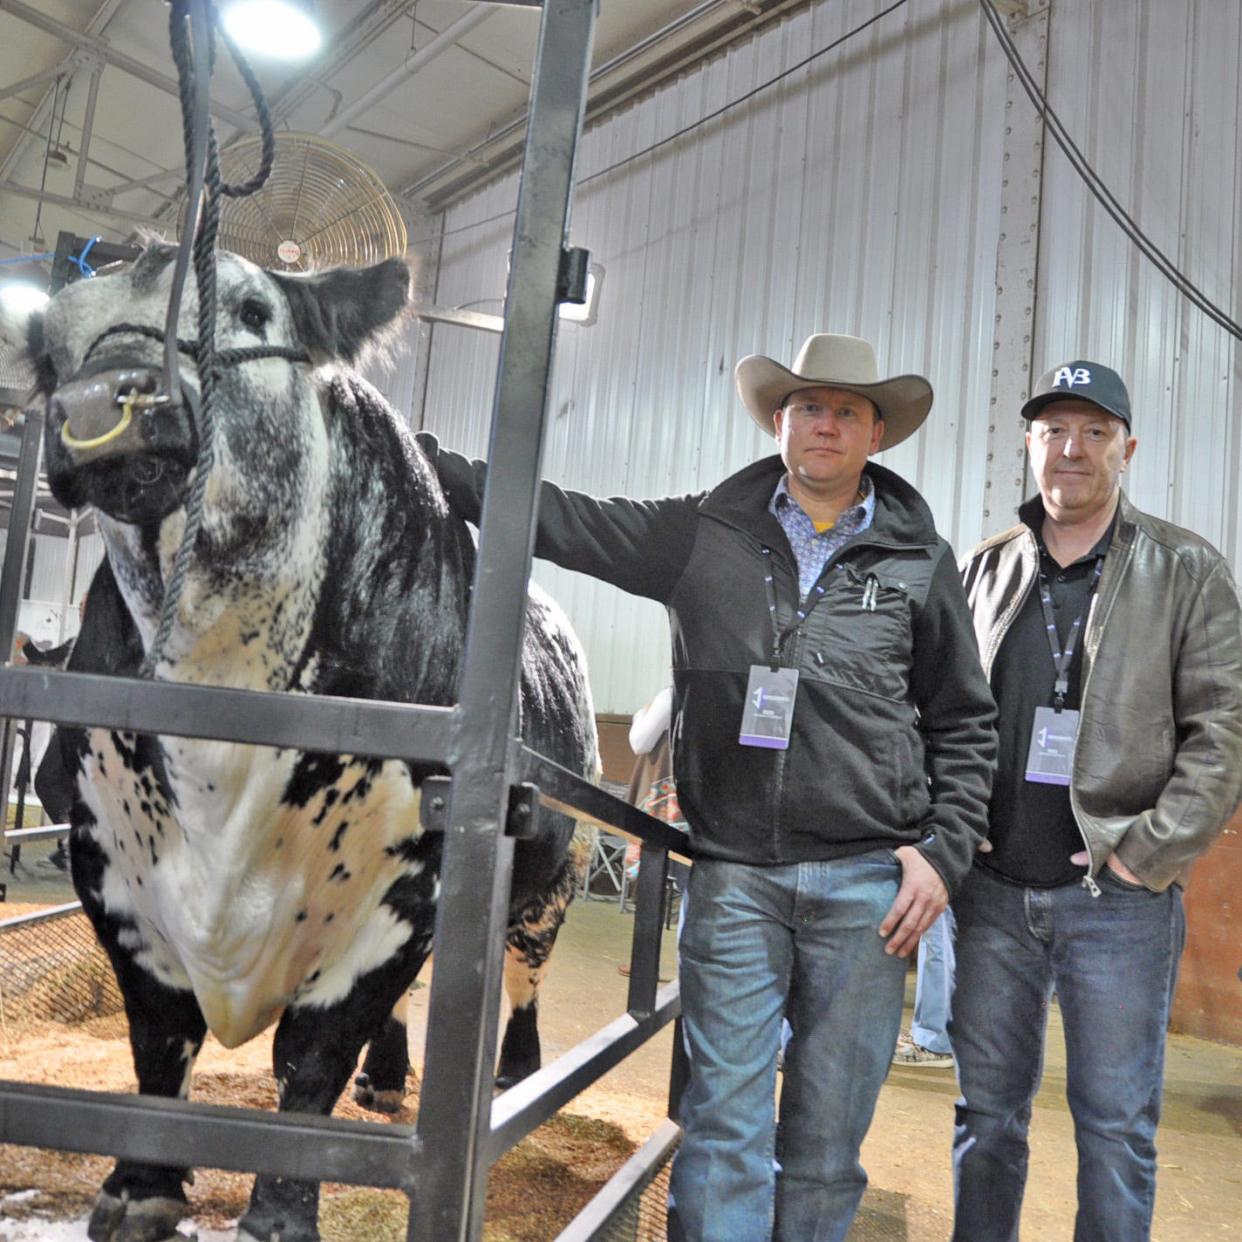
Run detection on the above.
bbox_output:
[668,850,905,1242]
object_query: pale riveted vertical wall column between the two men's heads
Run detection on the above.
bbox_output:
[982,5,1049,538]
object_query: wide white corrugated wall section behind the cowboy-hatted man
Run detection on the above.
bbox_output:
[425,0,1005,712]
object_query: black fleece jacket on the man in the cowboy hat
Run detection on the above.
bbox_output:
[417,432,996,893]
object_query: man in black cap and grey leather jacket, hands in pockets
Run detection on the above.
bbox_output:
[949,361,1242,1242]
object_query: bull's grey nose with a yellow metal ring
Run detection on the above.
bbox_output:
[51,366,169,466]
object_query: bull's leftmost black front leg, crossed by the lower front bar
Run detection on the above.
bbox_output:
[87,964,206,1242]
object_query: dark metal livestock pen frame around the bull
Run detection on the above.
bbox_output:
[0,0,684,1242]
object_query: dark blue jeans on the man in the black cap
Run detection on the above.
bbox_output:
[949,867,1186,1242]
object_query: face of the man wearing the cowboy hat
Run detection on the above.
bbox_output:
[776,388,884,492]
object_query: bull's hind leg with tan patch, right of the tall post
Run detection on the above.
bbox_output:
[496,859,578,1090]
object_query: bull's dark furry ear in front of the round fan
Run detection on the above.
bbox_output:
[271,258,410,363]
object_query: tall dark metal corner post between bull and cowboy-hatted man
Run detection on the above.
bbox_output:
[410,0,596,1242]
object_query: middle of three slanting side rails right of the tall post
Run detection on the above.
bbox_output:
[487,980,682,1163]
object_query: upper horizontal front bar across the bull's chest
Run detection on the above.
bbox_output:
[0,667,455,763]
